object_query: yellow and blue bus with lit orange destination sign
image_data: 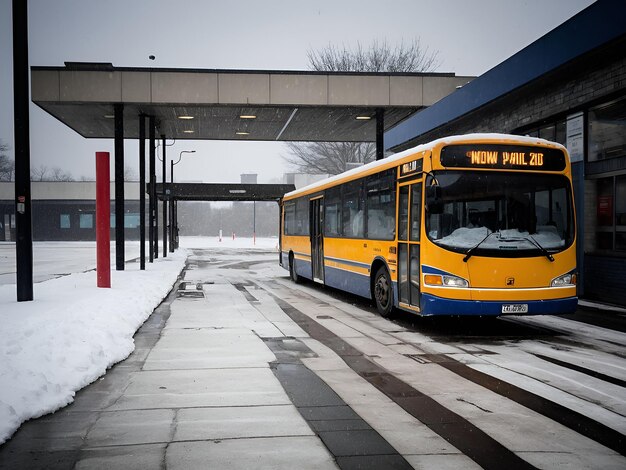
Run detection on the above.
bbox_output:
[280,134,577,316]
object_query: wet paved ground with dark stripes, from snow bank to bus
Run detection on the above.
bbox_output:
[0,249,626,470]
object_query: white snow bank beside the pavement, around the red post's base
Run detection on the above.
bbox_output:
[0,249,187,444]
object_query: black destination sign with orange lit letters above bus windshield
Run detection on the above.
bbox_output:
[441,144,565,171]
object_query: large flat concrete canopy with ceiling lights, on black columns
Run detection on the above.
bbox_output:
[31,62,473,142]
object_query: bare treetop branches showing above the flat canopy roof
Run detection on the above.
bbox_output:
[307,39,440,72]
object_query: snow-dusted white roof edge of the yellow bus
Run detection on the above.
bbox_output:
[284,133,567,199]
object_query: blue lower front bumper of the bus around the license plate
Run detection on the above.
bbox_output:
[421,294,578,316]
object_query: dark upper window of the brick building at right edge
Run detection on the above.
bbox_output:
[588,97,626,161]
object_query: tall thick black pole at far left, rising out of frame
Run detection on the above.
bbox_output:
[13,0,33,302]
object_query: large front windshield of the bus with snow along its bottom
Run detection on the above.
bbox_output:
[426,171,574,257]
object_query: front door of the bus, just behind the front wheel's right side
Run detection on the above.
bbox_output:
[398,181,422,311]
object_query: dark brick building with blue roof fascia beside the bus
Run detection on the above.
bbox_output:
[385,0,626,305]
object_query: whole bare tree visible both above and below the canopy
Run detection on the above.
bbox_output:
[283,39,439,174]
